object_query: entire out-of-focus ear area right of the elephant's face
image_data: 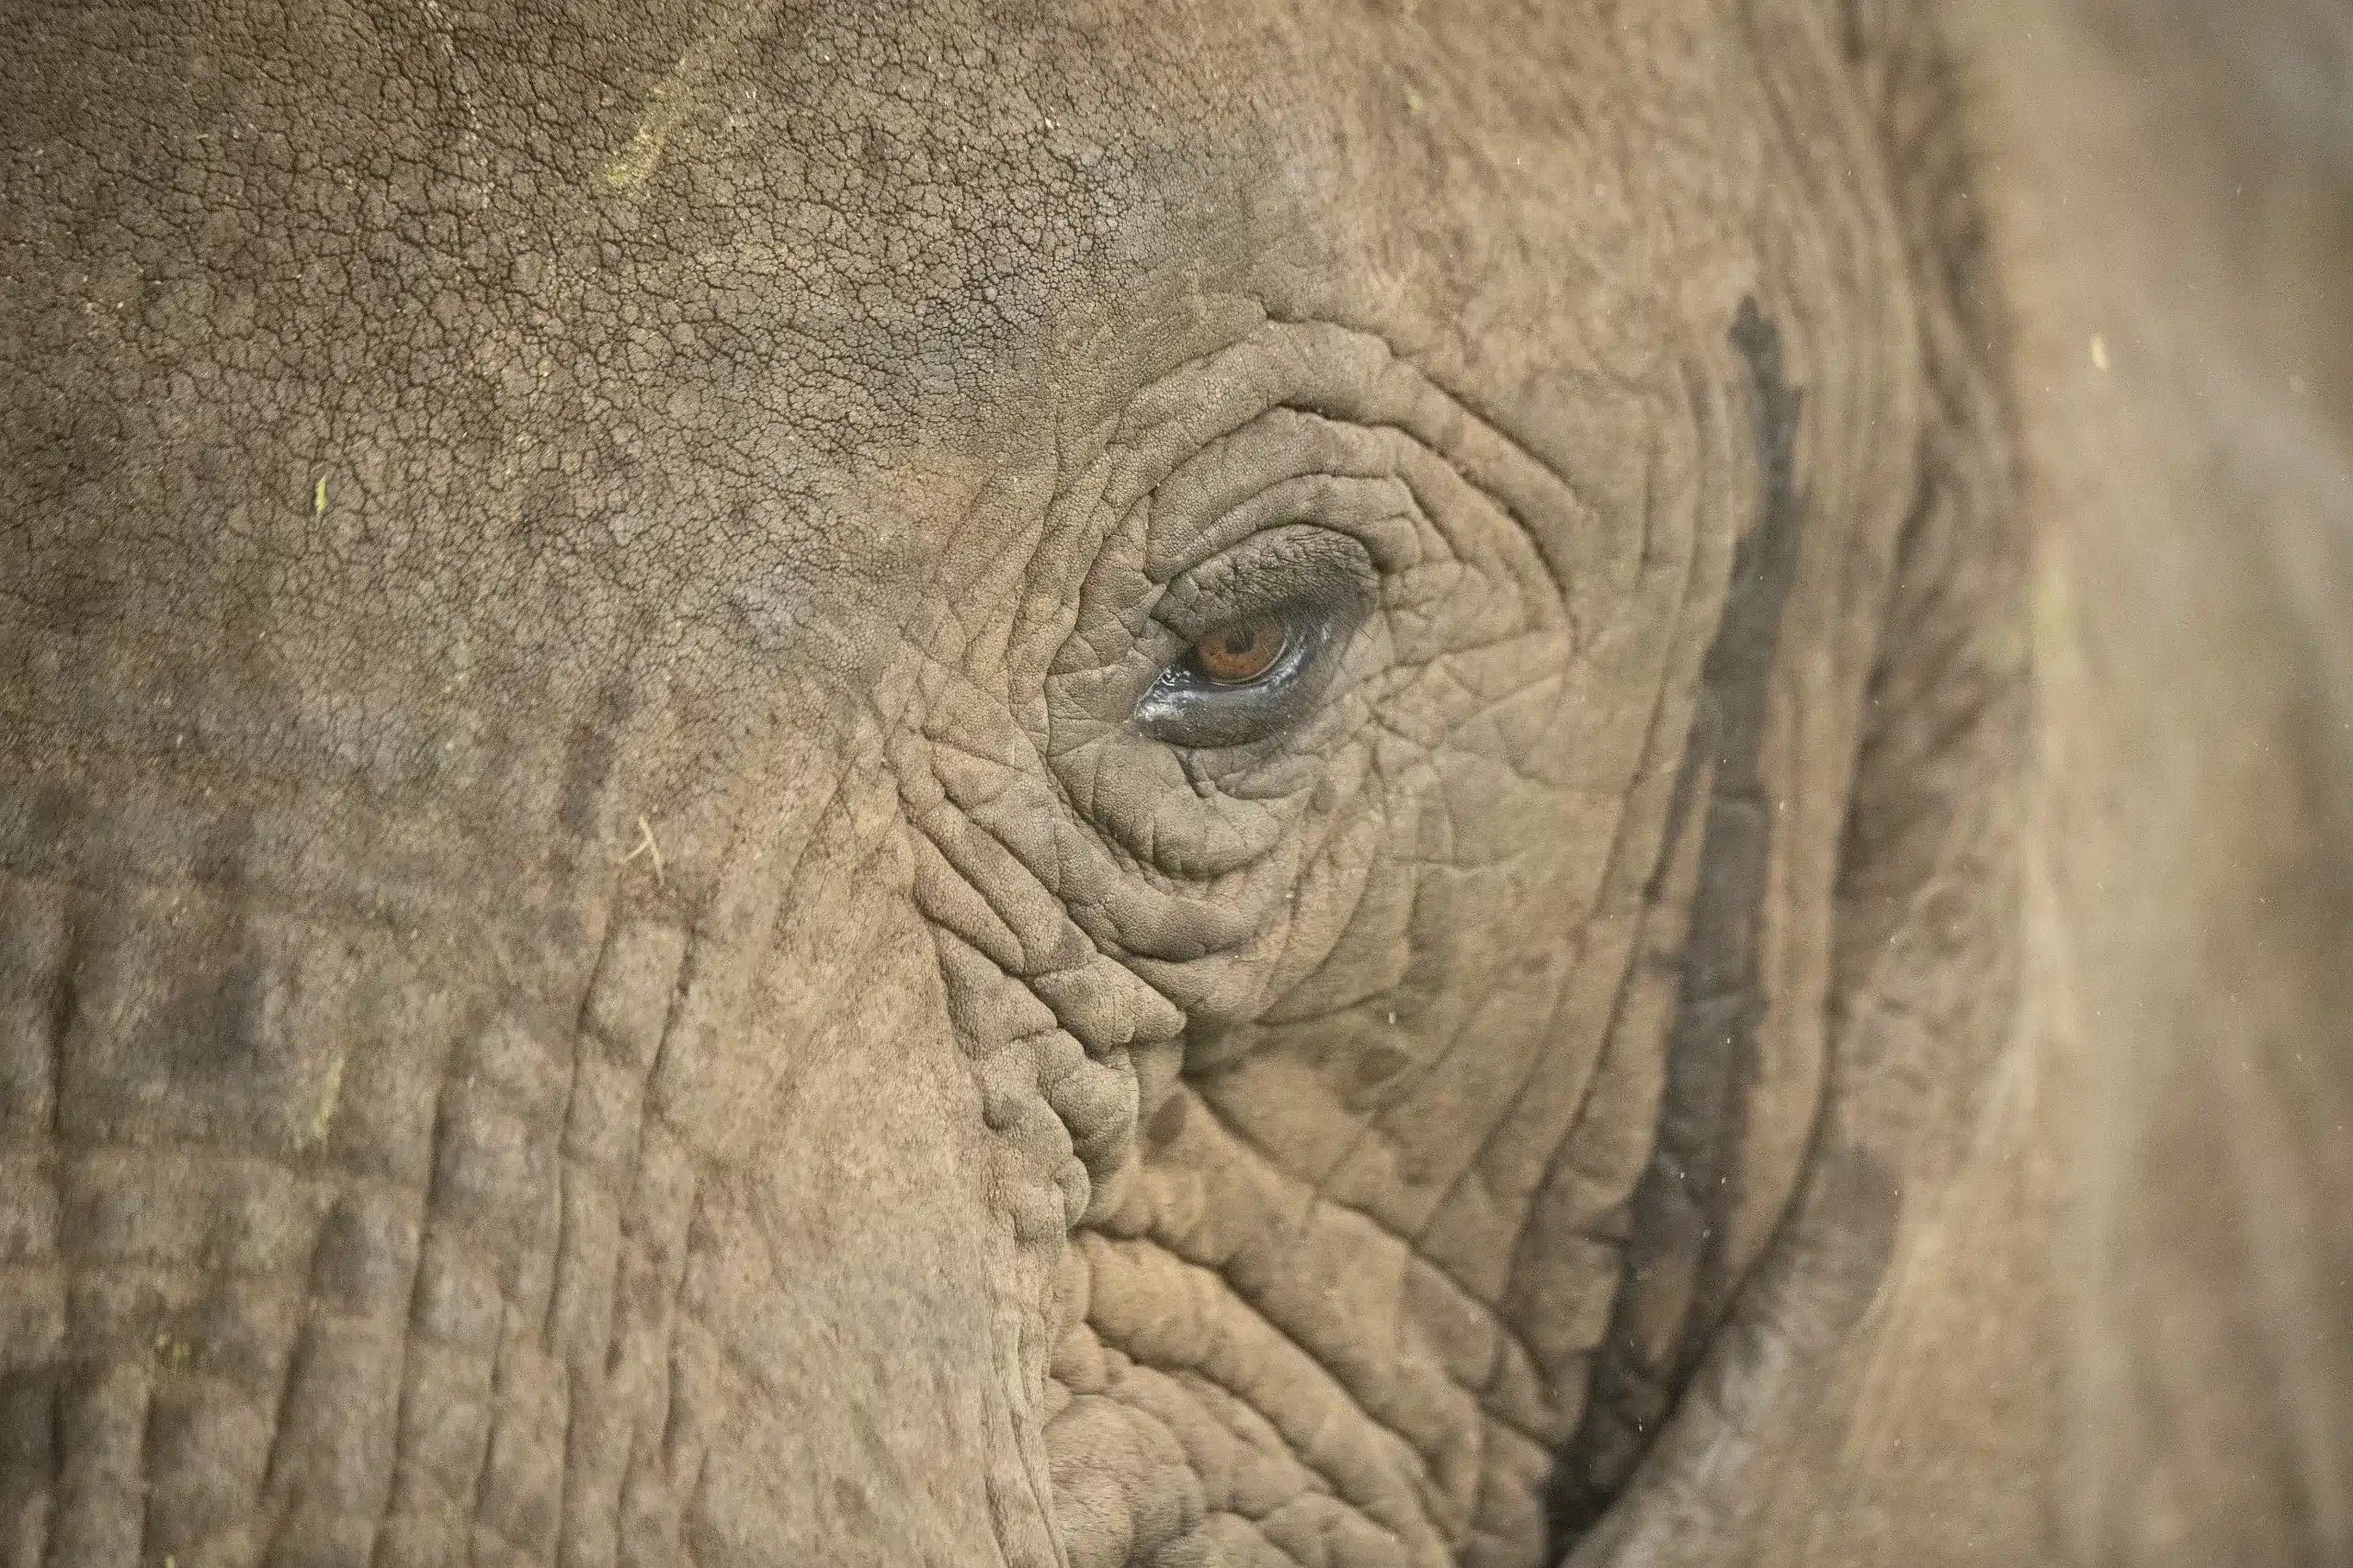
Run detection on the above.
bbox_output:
[1572,0,2353,1565]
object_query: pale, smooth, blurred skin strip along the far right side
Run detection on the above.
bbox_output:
[1929,0,2353,1563]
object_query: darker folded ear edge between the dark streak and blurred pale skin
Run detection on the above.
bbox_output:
[1563,5,2040,1568]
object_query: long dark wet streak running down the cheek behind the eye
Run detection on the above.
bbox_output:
[1553,299,1805,1544]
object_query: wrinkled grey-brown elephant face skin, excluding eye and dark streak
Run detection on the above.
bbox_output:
[0,3,1976,1568]
